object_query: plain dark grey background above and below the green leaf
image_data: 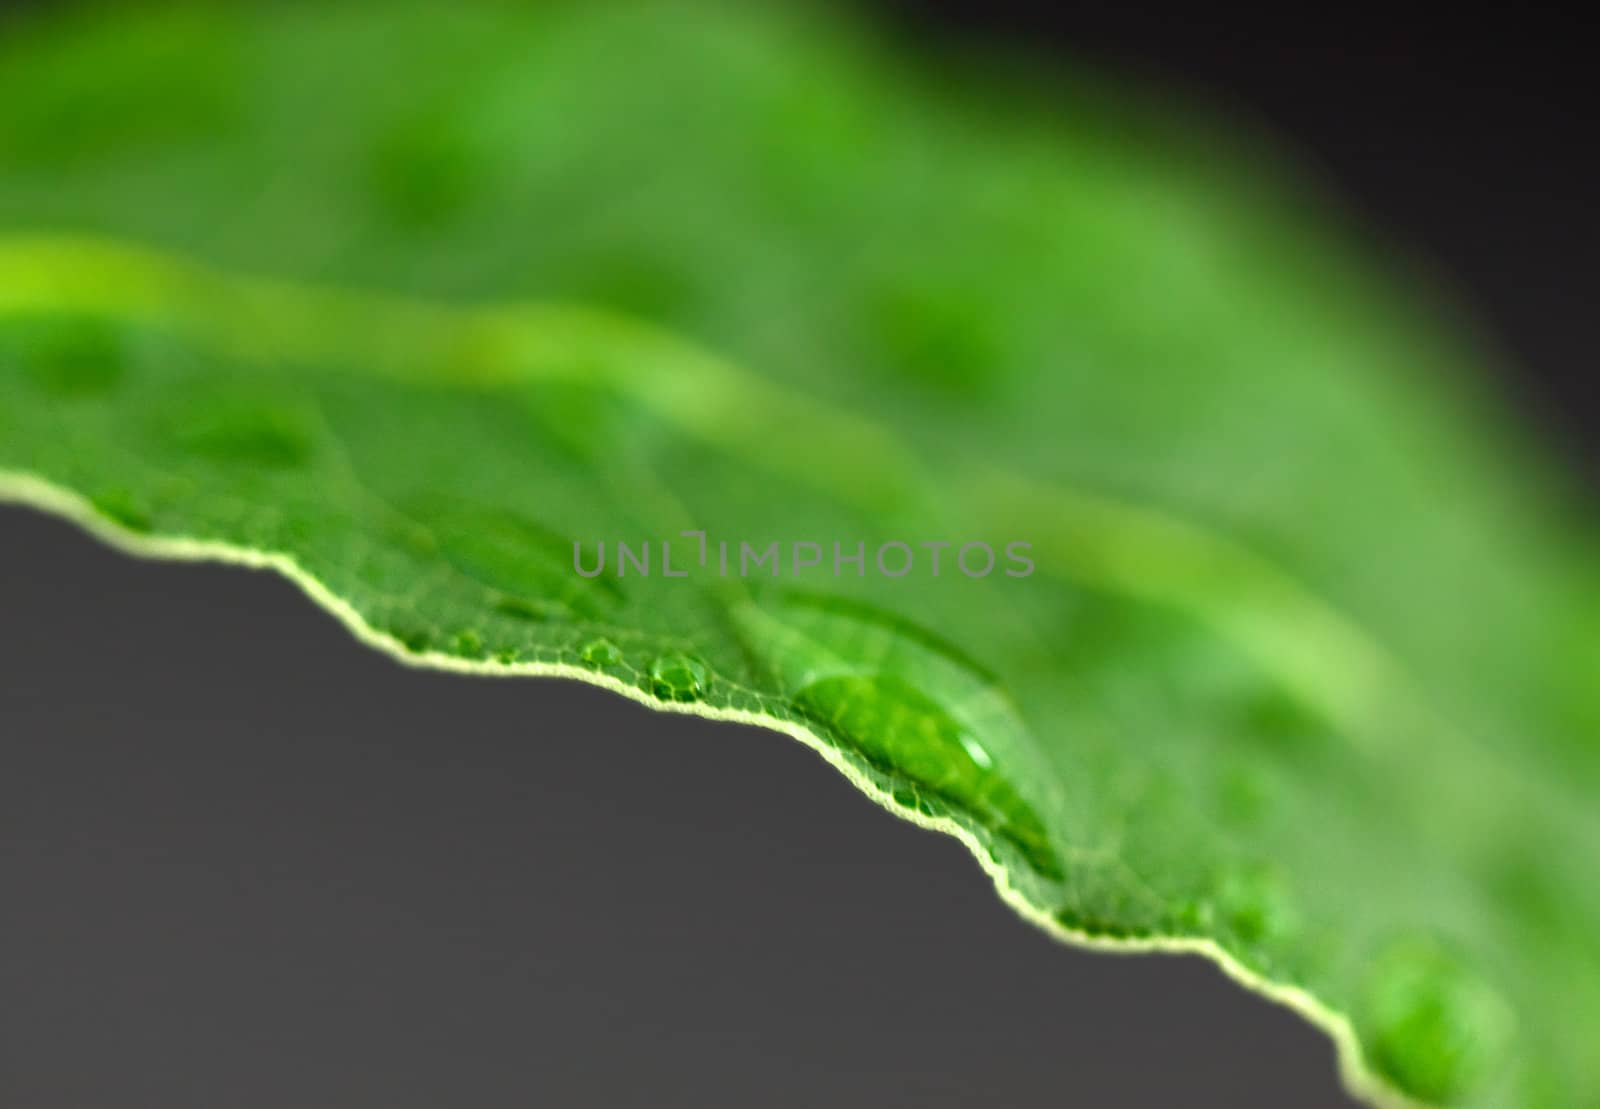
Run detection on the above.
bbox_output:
[0,3,1600,1109]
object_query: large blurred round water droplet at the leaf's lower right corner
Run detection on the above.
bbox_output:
[1363,938,1510,1103]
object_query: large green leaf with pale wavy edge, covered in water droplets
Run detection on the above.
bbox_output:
[0,3,1600,1106]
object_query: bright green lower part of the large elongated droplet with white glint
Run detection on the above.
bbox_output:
[795,674,1062,879]
